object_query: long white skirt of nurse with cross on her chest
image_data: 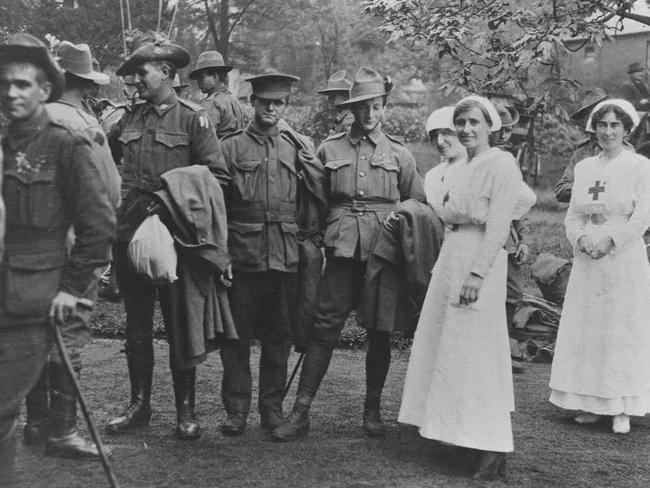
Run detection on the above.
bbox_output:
[550,238,650,415]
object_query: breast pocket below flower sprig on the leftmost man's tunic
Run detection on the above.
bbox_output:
[4,168,65,227]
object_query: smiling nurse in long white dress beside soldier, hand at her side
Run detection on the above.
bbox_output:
[399,96,534,479]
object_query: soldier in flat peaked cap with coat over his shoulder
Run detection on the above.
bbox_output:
[221,73,325,435]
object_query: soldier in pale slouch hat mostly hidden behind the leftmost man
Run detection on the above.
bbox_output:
[24,41,120,458]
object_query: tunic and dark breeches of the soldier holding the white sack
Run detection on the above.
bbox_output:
[109,93,229,362]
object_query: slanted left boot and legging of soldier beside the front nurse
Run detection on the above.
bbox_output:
[271,343,332,442]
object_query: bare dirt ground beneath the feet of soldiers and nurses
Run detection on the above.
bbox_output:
[13,339,650,488]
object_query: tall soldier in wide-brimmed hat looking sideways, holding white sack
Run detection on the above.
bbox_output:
[106,40,229,439]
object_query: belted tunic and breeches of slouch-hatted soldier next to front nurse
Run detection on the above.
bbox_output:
[313,124,425,347]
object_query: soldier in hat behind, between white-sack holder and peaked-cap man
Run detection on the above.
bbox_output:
[190,51,244,139]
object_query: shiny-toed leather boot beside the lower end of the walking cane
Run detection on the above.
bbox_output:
[45,363,99,459]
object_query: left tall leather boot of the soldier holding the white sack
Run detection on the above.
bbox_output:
[105,341,153,434]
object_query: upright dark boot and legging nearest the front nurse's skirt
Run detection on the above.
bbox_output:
[363,330,390,437]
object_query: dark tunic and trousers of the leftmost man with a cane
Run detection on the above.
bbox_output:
[0,111,115,462]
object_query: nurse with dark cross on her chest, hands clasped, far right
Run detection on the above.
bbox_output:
[550,99,650,434]
